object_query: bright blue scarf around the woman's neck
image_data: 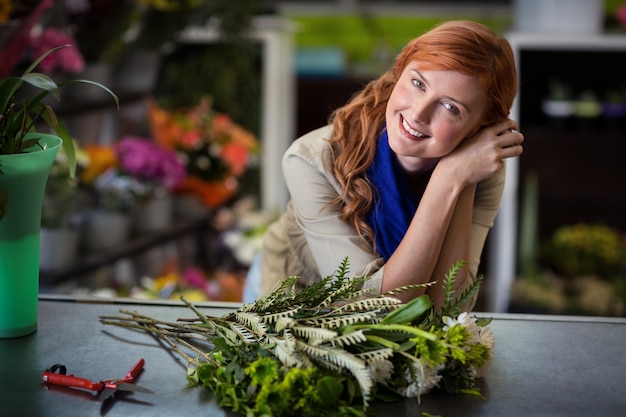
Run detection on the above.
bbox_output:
[367,129,419,261]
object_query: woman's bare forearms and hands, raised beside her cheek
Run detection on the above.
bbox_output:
[382,120,523,307]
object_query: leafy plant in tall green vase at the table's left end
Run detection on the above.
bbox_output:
[0,45,119,337]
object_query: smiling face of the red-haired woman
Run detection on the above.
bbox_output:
[386,62,487,172]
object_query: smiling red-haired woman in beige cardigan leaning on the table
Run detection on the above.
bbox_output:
[246,21,523,308]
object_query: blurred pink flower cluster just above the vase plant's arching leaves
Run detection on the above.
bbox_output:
[31,28,85,74]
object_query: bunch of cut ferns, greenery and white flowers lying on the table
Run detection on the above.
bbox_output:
[100,259,494,416]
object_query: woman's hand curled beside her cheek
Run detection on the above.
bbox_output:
[436,119,524,186]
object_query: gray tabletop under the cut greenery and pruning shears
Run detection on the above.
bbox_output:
[0,298,626,417]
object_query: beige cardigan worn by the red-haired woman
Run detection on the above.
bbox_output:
[261,126,505,295]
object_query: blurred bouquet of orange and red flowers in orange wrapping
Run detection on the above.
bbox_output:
[149,98,259,207]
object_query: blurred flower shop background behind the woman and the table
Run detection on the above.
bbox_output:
[0,0,626,316]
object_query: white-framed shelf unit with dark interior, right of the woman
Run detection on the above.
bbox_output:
[487,33,626,311]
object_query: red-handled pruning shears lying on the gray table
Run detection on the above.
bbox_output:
[42,359,152,401]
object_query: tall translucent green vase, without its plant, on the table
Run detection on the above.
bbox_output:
[0,133,62,338]
